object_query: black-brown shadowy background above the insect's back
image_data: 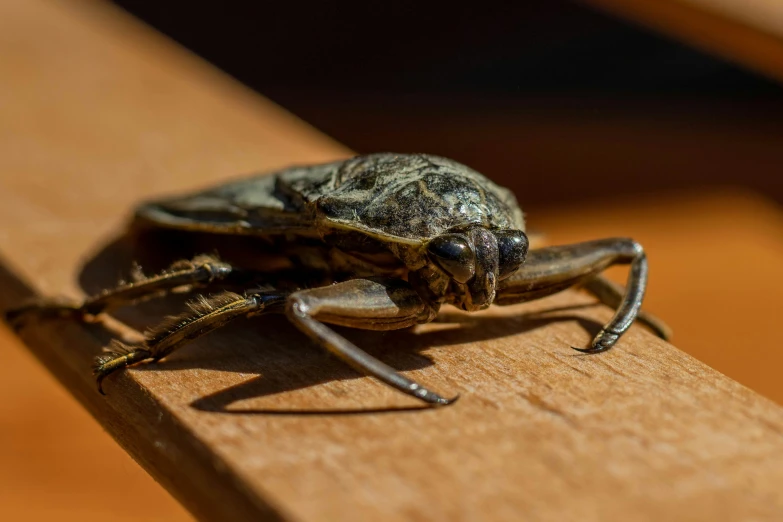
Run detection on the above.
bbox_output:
[110,0,783,205]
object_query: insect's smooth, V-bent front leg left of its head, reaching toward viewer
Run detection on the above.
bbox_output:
[286,278,457,406]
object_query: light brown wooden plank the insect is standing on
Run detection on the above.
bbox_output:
[0,0,783,520]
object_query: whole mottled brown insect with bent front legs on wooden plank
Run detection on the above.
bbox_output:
[8,153,668,405]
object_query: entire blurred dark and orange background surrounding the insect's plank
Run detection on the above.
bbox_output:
[0,0,783,521]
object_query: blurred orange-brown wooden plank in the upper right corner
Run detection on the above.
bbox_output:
[581,0,783,80]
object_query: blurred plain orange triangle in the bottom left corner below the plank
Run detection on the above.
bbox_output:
[0,320,191,522]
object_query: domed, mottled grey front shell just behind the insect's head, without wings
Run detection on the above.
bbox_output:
[308,154,525,241]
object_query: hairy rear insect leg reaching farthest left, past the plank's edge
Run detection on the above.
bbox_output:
[6,255,235,327]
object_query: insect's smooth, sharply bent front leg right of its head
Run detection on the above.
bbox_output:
[495,238,647,353]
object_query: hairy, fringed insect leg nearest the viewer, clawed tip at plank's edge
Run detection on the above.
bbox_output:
[93,291,286,393]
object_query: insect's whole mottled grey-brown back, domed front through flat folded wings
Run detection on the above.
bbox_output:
[137,153,524,244]
